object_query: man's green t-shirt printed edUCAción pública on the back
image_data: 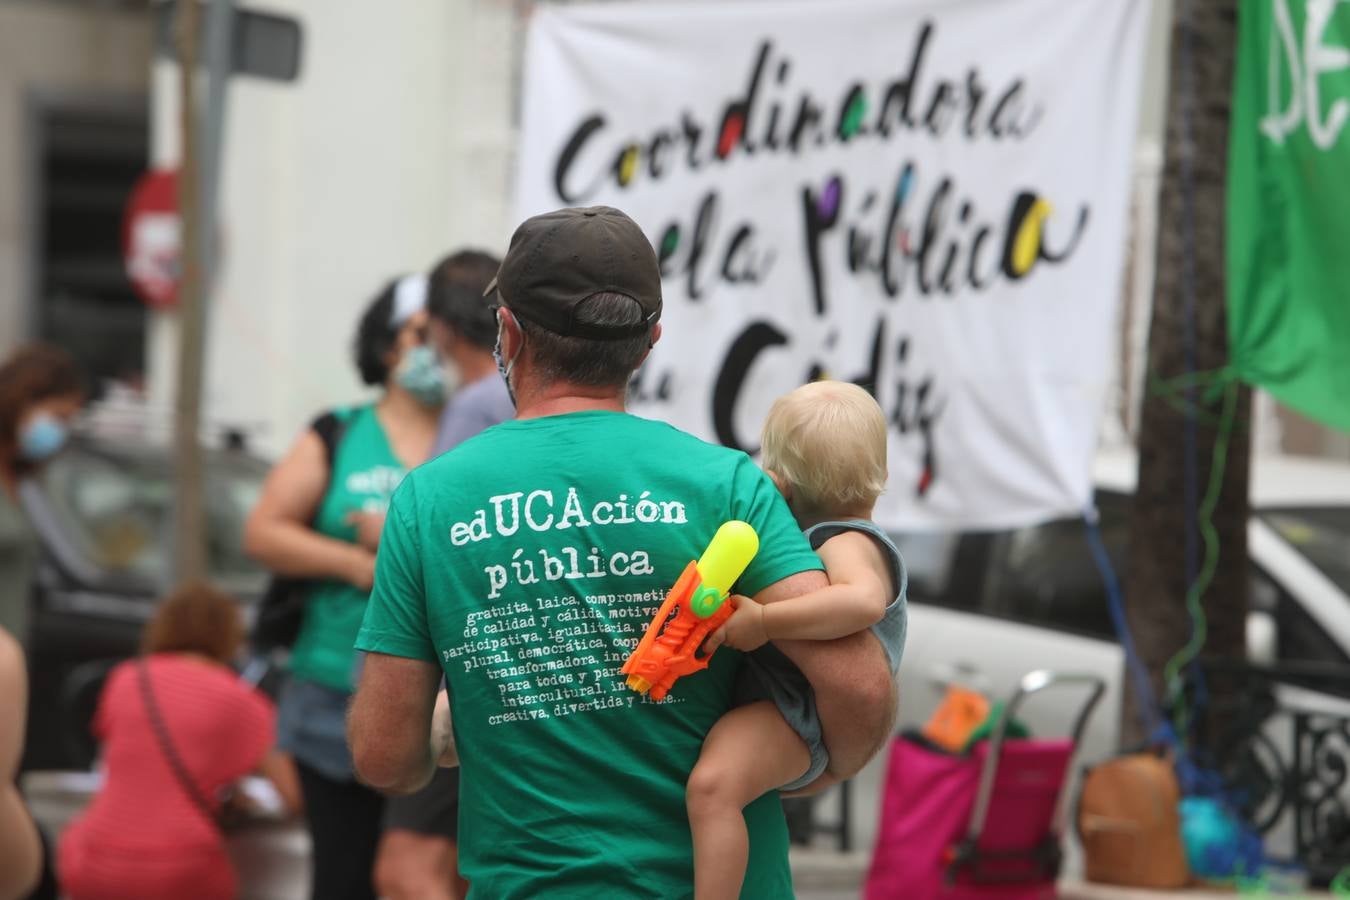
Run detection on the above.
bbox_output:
[356,412,821,900]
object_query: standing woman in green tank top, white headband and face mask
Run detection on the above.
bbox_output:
[244,275,446,900]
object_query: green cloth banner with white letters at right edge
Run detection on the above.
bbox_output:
[1227,0,1350,430]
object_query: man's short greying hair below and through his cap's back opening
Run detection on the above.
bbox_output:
[508,293,652,387]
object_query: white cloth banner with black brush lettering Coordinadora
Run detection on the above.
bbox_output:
[516,0,1146,529]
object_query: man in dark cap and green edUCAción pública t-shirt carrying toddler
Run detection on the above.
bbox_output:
[348,208,894,900]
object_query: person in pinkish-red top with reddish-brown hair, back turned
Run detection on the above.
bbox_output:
[57,584,298,900]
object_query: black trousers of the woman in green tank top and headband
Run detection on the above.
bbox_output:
[296,760,385,900]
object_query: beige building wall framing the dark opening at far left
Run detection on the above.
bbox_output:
[0,3,151,355]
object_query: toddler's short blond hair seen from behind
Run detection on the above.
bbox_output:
[761,382,886,510]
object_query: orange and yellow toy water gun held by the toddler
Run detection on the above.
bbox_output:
[620,522,759,700]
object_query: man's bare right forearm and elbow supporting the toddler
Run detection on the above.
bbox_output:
[755,571,895,779]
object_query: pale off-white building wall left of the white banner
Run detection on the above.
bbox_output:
[150,0,516,453]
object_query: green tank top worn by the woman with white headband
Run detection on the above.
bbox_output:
[290,406,406,691]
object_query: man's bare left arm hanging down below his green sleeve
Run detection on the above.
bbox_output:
[347,653,450,793]
